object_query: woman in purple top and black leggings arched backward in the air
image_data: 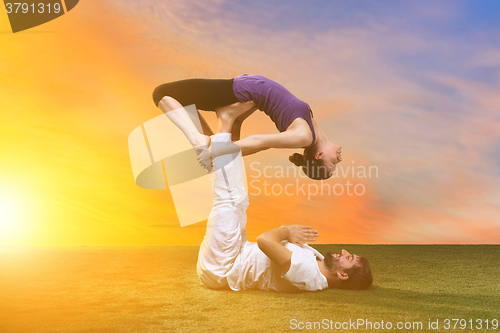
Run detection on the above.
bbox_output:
[153,74,342,180]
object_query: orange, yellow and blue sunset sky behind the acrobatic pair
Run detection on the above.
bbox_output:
[0,0,500,245]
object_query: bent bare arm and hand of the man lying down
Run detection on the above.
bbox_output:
[257,225,318,274]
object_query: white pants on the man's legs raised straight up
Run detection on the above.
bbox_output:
[196,133,248,289]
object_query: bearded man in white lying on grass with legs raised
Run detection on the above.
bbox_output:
[197,133,373,292]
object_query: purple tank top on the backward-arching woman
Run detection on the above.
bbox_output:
[233,74,316,148]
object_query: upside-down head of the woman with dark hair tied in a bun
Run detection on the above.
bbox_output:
[289,140,342,180]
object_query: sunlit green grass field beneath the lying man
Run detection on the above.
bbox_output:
[0,245,500,333]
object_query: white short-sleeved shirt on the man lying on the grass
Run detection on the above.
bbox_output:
[227,242,328,292]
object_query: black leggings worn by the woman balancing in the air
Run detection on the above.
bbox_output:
[153,79,238,111]
